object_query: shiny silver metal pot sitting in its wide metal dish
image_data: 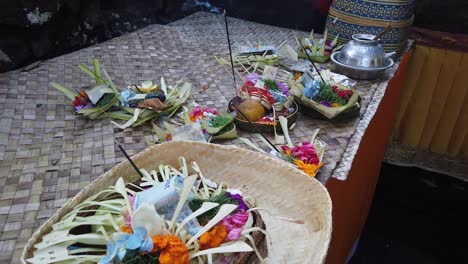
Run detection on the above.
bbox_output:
[331,34,395,79]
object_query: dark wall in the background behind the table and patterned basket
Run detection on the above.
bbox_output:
[0,0,468,72]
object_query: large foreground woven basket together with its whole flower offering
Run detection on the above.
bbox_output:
[21,141,331,264]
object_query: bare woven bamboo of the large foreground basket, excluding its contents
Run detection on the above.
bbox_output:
[21,141,332,264]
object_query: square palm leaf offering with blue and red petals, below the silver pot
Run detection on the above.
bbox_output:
[289,70,360,119]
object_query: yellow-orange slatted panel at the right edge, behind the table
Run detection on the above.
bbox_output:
[393,44,468,159]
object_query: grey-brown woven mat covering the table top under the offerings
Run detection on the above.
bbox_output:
[0,13,397,263]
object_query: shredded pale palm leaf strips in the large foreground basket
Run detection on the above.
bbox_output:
[27,157,268,264]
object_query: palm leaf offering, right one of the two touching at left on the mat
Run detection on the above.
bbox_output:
[109,77,192,129]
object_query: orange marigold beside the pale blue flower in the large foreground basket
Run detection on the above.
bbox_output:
[151,235,189,264]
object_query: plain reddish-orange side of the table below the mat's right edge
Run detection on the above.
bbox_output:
[325,52,411,264]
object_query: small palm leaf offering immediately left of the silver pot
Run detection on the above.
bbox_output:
[296,29,342,63]
